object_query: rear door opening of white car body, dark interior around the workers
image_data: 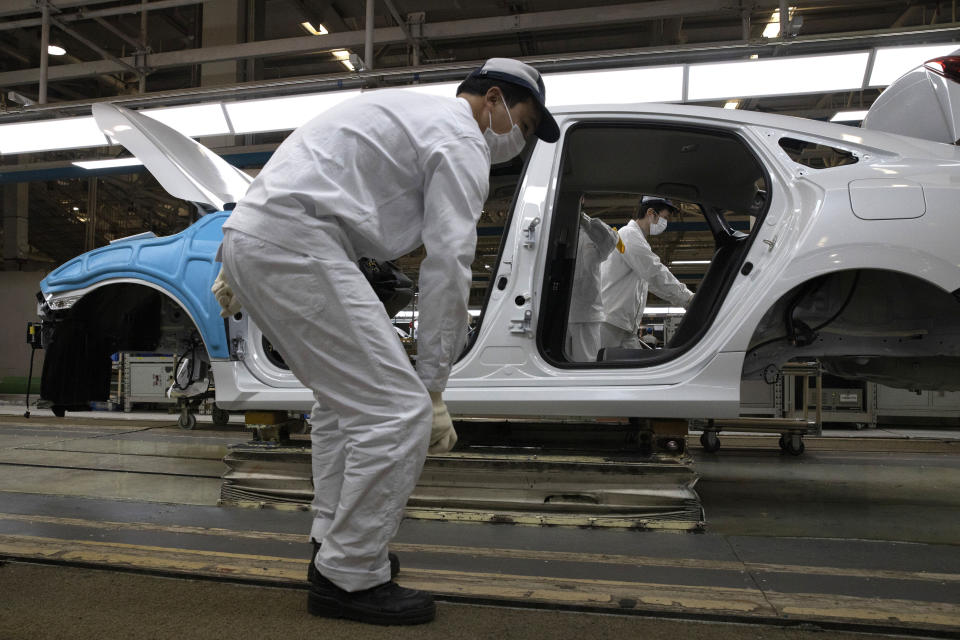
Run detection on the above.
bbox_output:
[537,123,769,367]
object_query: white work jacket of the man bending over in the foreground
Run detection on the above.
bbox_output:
[223,89,490,391]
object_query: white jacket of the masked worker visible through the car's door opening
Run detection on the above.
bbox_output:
[600,220,693,333]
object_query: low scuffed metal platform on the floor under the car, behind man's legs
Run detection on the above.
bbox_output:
[220,443,704,531]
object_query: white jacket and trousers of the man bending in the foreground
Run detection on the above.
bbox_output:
[222,89,490,591]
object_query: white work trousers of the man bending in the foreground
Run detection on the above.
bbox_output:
[222,228,433,591]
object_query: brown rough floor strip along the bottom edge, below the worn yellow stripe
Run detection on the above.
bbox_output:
[0,563,928,640]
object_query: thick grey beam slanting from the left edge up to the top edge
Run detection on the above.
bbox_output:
[0,0,740,86]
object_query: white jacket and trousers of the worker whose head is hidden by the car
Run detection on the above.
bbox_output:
[566,212,623,362]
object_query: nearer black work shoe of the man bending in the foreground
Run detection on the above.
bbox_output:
[307,571,437,625]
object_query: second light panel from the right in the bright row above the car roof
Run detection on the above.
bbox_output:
[687,52,870,100]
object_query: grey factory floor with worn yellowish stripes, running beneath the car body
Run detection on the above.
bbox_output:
[0,406,960,640]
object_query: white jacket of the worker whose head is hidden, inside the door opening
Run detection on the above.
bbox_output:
[567,213,618,322]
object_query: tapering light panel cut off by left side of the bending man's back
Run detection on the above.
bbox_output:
[224,91,360,134]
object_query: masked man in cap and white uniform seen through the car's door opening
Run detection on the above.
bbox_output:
[600,196,693,349]
